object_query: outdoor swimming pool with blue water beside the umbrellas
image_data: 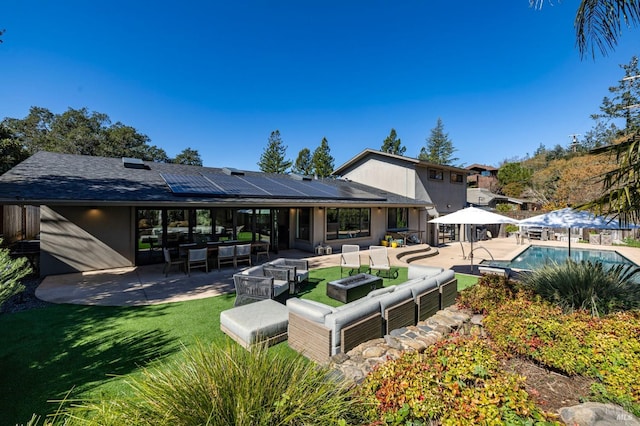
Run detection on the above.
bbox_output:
[482,246,635,270]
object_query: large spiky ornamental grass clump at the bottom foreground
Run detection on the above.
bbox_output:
[56,344,359,425]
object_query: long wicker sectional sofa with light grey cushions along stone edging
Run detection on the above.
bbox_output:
[287,265,457,363]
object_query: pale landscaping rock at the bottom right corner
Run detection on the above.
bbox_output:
[560,402,640,426]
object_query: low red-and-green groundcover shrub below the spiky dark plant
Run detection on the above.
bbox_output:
[483,298,640,415]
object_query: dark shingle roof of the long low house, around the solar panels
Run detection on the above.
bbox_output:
[0,151,430,206]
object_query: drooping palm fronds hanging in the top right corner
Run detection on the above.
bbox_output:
[529,0,640,57]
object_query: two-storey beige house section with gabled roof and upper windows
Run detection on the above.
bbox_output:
[334,149,467,244]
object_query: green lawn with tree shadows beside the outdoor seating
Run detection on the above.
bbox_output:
[0,267,477,425]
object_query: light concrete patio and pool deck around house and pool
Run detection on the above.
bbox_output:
[36,237,640,306]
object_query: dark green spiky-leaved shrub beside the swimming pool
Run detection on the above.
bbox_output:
[523,259,640,316]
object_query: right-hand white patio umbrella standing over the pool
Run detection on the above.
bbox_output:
[519,207,636,257]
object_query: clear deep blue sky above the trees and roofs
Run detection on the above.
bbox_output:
[0,0,640,170]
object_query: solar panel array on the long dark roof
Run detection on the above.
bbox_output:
[161,173,385,201]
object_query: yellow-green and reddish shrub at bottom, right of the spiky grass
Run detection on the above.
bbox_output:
[361,336,551,425]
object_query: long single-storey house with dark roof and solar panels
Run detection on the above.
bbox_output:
[0,152,432,276]
